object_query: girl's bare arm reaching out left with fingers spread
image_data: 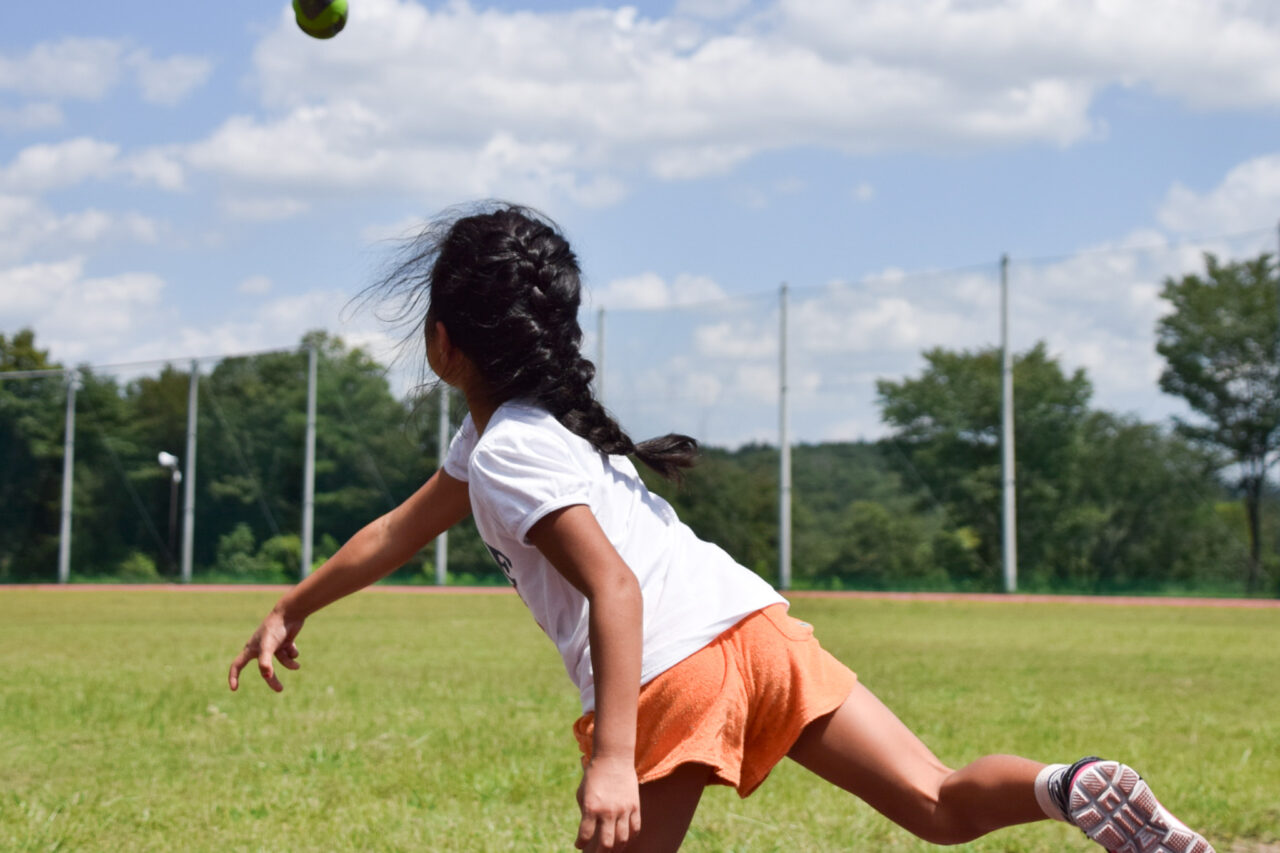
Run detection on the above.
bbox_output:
[227,469,471,693]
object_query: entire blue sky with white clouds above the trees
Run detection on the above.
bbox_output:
[0,0,1280,443]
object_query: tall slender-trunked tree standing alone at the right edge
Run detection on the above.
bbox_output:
[1156,254,1280,593]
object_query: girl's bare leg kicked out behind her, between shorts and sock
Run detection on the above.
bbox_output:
[787,683,1044,844]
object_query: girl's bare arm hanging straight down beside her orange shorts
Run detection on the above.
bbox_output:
[529,505,644,852]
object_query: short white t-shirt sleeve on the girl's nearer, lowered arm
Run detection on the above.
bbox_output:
[470,424,591,542]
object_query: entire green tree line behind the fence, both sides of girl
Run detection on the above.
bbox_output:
[0,255,1280,593]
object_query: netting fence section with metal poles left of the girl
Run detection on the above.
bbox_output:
[0,336,500,583]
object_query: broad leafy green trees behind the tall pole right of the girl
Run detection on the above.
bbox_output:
[878,345,1238,592]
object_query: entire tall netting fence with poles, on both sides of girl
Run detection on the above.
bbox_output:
[0,229,1280,594]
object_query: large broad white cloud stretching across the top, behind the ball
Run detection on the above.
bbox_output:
[175,0,1280,205]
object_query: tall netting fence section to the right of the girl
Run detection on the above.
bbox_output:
[584,229,1280,594]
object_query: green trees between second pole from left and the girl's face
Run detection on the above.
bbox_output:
[195,332,450,571]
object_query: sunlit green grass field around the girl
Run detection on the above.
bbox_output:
[0,589,1280,853]
